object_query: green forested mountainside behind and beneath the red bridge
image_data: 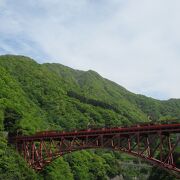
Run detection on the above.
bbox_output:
[0,55,180,180]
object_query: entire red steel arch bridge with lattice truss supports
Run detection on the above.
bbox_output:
[9,123,180,175]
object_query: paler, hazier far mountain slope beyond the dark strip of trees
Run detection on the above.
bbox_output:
[44,64,180,120]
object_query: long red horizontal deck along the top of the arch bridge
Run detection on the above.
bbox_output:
[11,123,180,141]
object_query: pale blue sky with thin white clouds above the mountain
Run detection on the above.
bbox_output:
[0,0,180,99]
